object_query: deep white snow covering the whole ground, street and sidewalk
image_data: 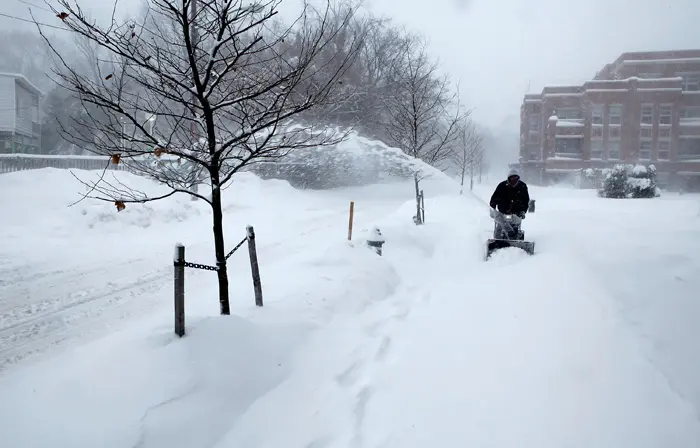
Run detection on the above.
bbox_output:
[0,164,700,448]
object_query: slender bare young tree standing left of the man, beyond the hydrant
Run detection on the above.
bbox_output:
[385,35,461,224]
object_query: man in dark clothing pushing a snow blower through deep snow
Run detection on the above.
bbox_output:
[486,169,535,259]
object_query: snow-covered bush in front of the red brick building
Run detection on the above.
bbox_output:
[586,165,660,199]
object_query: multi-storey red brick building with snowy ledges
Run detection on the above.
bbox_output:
[519,50,700,190]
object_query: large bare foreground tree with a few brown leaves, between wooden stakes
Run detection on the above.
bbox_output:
[37,0,361,314]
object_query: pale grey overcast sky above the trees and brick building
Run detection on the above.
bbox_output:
[5,0,700,131]
